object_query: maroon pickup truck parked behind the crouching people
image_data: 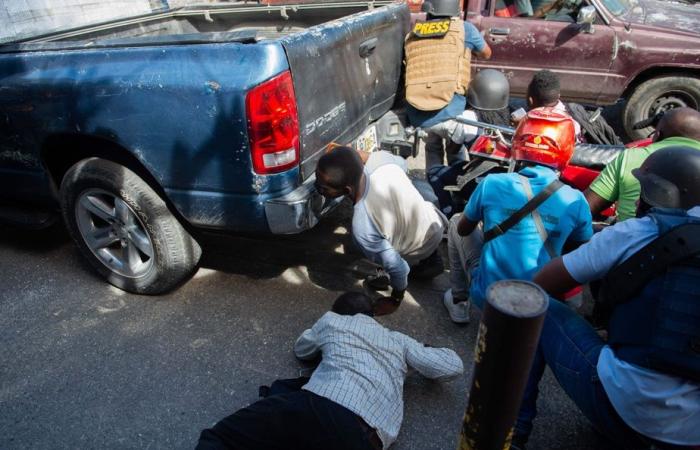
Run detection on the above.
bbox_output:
[408,0,700,139]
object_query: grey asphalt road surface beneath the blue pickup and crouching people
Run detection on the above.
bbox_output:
[0,198,603,450]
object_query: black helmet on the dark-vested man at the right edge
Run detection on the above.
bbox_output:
[628,145,700,210]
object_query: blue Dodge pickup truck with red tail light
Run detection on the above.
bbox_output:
[0,0,410,294]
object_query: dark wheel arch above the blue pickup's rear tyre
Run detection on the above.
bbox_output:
[41,133,193,232]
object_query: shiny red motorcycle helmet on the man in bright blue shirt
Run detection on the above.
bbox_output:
[513,108,576,171]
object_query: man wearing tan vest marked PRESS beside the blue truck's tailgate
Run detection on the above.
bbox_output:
[406,0,491,170]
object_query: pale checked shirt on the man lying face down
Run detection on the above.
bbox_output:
[294,312,464,449]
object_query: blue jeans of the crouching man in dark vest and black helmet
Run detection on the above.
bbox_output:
[514,299,650,448]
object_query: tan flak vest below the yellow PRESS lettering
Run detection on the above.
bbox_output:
[405,18,471,111]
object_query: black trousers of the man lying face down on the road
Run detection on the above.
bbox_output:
[197,381,377,450]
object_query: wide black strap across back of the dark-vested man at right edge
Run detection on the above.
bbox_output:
[601,223,700,305]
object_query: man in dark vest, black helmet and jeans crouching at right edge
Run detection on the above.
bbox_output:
[511,146,700,449]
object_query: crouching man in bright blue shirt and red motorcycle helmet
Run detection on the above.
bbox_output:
[443,110,593,323]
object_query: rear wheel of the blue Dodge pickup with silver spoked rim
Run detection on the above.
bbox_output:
[60,158,202,294]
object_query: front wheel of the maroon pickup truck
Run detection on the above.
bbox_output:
[622,76,700,140]
